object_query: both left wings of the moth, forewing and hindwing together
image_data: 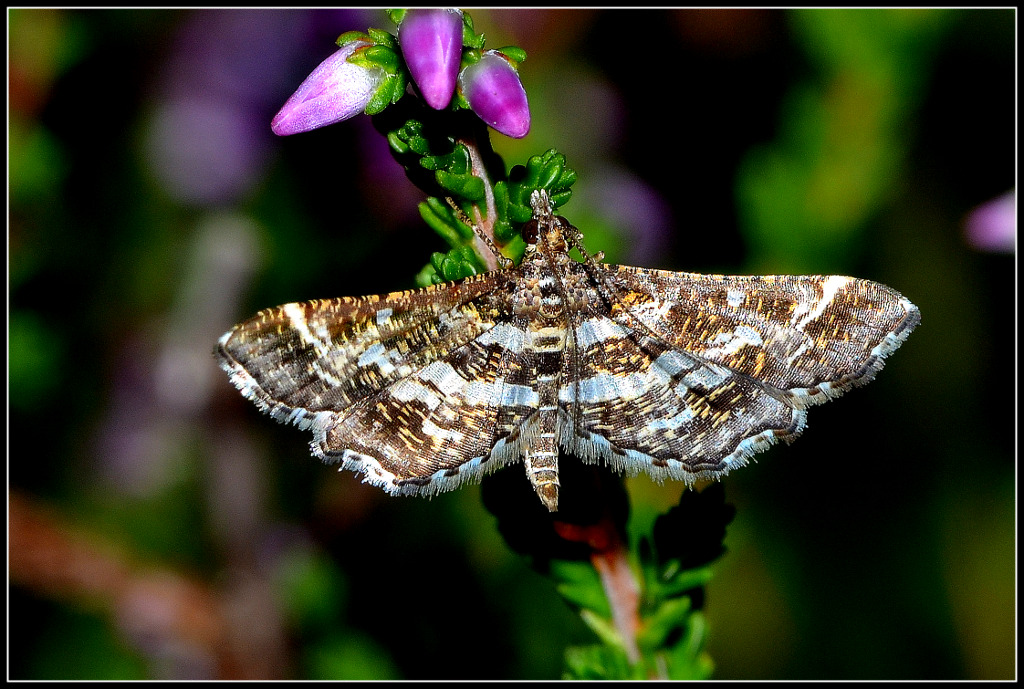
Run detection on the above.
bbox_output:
[217,273,537,493]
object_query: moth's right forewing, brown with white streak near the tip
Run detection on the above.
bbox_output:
[606,265,921,407]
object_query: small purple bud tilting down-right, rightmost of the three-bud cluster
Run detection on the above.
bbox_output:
[459,50,529,139]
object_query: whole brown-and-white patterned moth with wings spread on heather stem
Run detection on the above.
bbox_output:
[216,190,921,512]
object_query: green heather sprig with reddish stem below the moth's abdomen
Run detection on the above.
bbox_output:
[482,457,734,679]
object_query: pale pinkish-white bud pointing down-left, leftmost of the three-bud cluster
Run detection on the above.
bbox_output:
[270,41,385,136]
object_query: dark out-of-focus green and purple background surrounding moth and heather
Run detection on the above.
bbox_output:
[8,9,1017,679]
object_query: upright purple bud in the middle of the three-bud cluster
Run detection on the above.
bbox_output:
[398,9,462,110]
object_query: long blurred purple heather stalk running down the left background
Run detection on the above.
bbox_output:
[98,10,385,679]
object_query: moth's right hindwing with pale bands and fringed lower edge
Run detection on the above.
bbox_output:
[559,264,806,484]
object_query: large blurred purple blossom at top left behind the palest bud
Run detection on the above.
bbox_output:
[144,10,369,206]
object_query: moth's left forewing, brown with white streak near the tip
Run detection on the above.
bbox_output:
[222,276,512,428]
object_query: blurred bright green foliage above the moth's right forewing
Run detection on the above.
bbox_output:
[737,9,949,272]
